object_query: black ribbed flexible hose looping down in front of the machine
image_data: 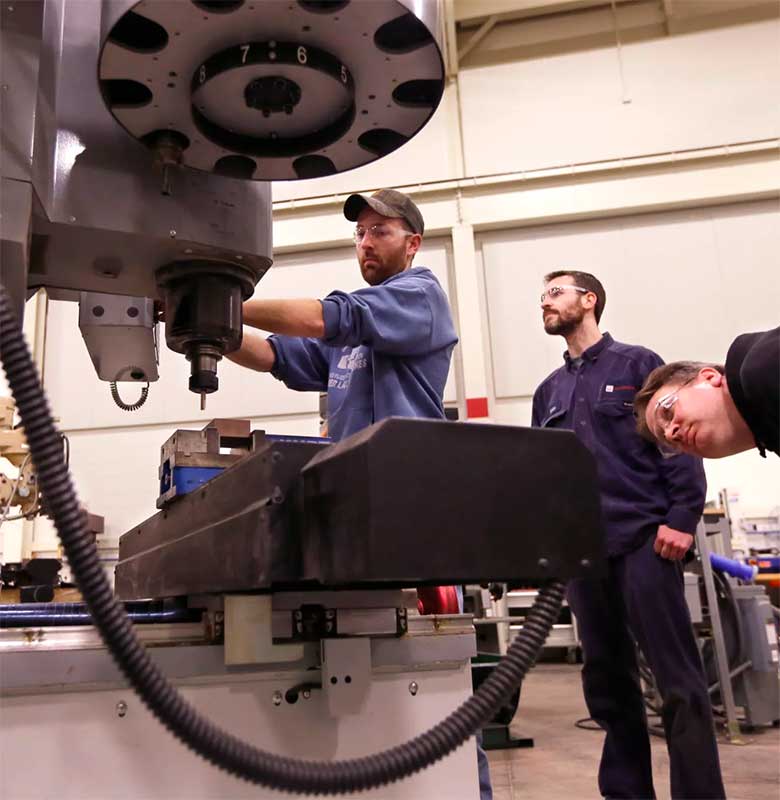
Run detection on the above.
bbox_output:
[0,284,565,794]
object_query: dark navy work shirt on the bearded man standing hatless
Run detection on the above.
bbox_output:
[533,333,707,556]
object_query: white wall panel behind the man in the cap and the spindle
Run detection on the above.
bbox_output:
[45,239,455,430]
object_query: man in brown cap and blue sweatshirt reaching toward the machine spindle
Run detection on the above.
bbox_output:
[228,189,493,800]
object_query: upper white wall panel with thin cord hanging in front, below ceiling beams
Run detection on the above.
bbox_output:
[459,20,780,175]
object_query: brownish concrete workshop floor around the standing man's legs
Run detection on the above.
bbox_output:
[488,663,780,800]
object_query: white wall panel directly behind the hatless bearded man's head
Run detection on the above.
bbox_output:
[481,201,780,398]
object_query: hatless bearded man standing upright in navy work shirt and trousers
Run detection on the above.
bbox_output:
[533,270,725,800]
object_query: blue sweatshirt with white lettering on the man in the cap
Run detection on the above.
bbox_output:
[268,267,458,441]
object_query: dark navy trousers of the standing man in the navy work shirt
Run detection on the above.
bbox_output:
[567,534,726,800]
